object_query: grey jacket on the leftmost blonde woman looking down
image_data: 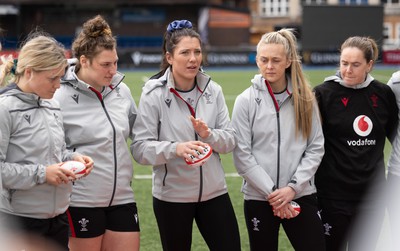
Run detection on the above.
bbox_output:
[0,84,77,219]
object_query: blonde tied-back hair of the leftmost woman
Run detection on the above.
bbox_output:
[4,33,68,83]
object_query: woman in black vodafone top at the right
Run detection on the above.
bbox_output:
[315,36,398,251]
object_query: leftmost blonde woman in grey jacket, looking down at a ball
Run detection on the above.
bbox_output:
[0,34,93,250]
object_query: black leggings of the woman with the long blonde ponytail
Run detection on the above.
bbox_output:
[244,195,325,251]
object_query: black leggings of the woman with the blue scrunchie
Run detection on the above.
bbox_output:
[153,194,240,251]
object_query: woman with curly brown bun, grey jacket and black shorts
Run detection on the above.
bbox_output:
[55,16,140,251]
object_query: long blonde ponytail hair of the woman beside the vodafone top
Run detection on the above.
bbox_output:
[257,28,314,138]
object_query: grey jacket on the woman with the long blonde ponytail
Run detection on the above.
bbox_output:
[232,74,324,201]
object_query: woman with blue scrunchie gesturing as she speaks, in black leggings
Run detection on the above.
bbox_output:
[131,20,240,251]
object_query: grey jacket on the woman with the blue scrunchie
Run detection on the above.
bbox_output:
[131,69,236,202]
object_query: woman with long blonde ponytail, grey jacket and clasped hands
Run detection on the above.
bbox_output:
[232,29,325,251]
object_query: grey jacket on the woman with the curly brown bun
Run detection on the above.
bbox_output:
[54,64,137,207]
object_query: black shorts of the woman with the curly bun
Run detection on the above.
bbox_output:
[67,203,140,238]
